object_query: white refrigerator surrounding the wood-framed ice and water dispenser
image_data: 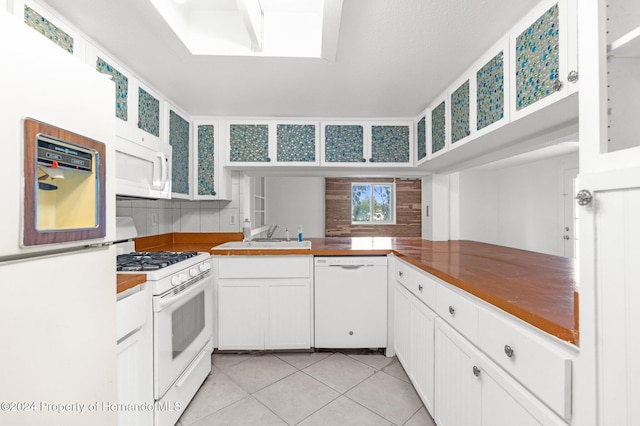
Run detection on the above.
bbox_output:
[0,11,117,425]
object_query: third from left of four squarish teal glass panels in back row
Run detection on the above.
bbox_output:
[324,124,365,163]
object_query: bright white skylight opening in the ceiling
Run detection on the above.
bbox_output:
[149,0,342,61]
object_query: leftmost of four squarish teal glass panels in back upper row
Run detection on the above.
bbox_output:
[229,124,270,163]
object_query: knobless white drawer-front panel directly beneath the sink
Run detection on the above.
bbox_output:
[218,256,313,278]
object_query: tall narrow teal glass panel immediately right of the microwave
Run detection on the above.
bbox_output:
[169,111,189,194]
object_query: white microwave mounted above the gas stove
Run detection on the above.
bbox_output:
[115,136,172,199]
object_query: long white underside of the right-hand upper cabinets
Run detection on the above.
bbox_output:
[418,94,578,174]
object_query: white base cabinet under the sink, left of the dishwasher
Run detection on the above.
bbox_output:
[214,256,313,350]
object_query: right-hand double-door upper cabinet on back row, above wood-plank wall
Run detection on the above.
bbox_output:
[321,120,414,167]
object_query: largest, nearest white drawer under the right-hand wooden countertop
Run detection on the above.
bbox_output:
[478,309,572,420]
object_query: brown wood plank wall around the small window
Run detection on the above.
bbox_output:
[325,178,422,237]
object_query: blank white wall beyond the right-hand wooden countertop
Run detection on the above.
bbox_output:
[457,153,578,256]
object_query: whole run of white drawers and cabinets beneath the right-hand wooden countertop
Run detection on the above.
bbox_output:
[393,259,574,426]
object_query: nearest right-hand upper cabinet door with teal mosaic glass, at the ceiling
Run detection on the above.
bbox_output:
[509,0,578,120]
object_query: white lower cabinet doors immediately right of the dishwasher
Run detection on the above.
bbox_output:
[394,282,436,413]
